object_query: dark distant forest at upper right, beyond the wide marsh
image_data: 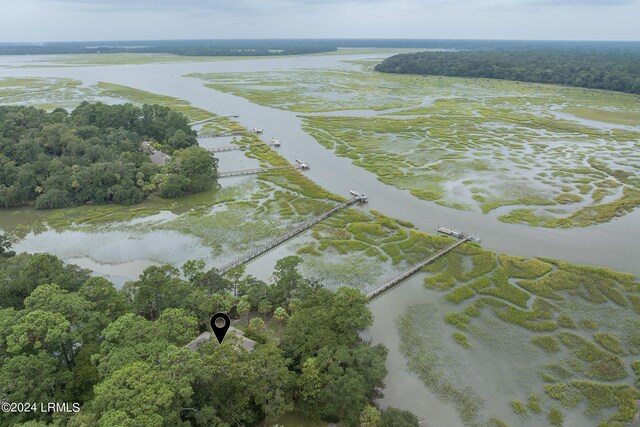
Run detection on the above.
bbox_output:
[375,49,640,94]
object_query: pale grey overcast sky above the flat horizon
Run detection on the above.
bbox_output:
[0,0,640,42]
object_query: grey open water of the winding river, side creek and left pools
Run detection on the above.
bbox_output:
[0,55,640,426]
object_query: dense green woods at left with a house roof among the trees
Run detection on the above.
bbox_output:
[0,102,217,209]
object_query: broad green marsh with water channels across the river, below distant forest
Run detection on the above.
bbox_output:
[191,61,640,227]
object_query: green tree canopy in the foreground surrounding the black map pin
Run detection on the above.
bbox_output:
[0,242,418,427]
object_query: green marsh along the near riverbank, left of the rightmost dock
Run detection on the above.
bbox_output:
[3,81,460,286]
